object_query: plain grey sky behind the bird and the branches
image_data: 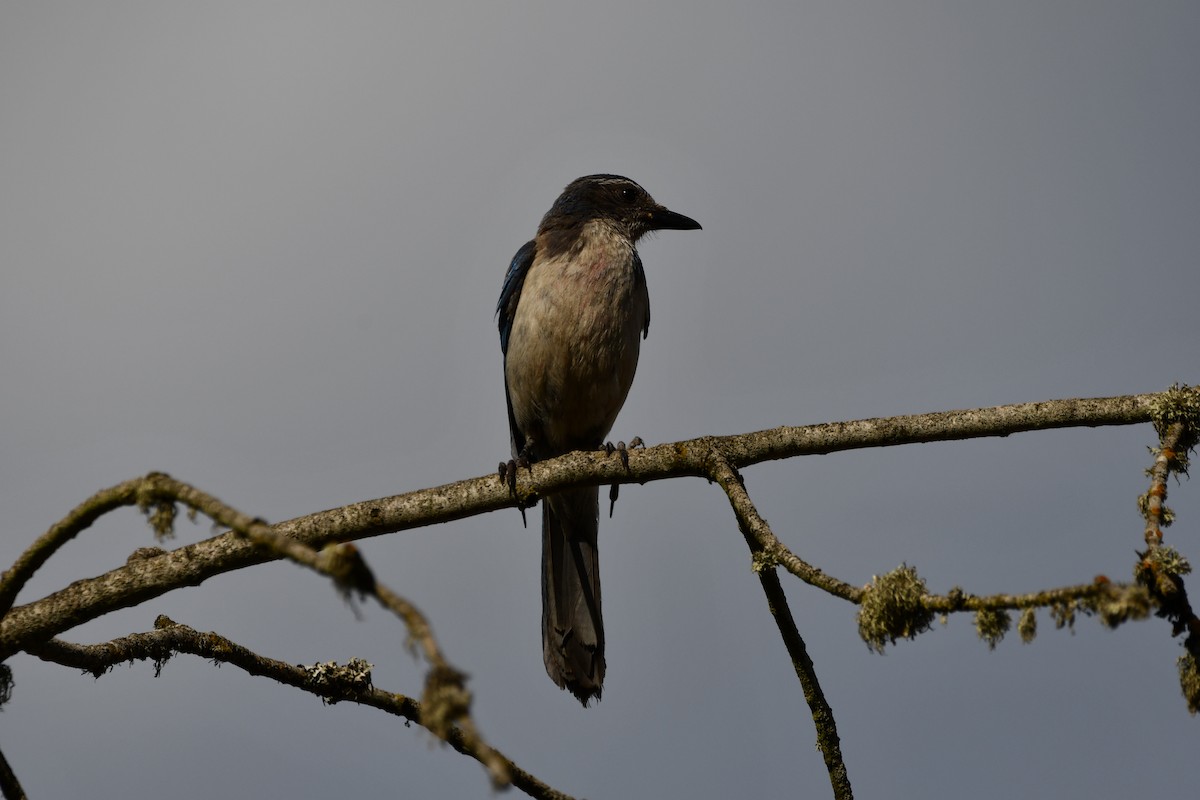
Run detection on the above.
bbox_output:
[0,0,1200,799]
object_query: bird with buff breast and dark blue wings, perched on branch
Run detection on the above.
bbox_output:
[496,174,701,708]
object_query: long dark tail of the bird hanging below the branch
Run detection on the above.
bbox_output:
[541,488,605,705]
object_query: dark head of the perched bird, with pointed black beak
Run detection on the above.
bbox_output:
[538,175,700,242]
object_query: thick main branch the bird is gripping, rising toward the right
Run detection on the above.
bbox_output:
[0,390,1180,660]
